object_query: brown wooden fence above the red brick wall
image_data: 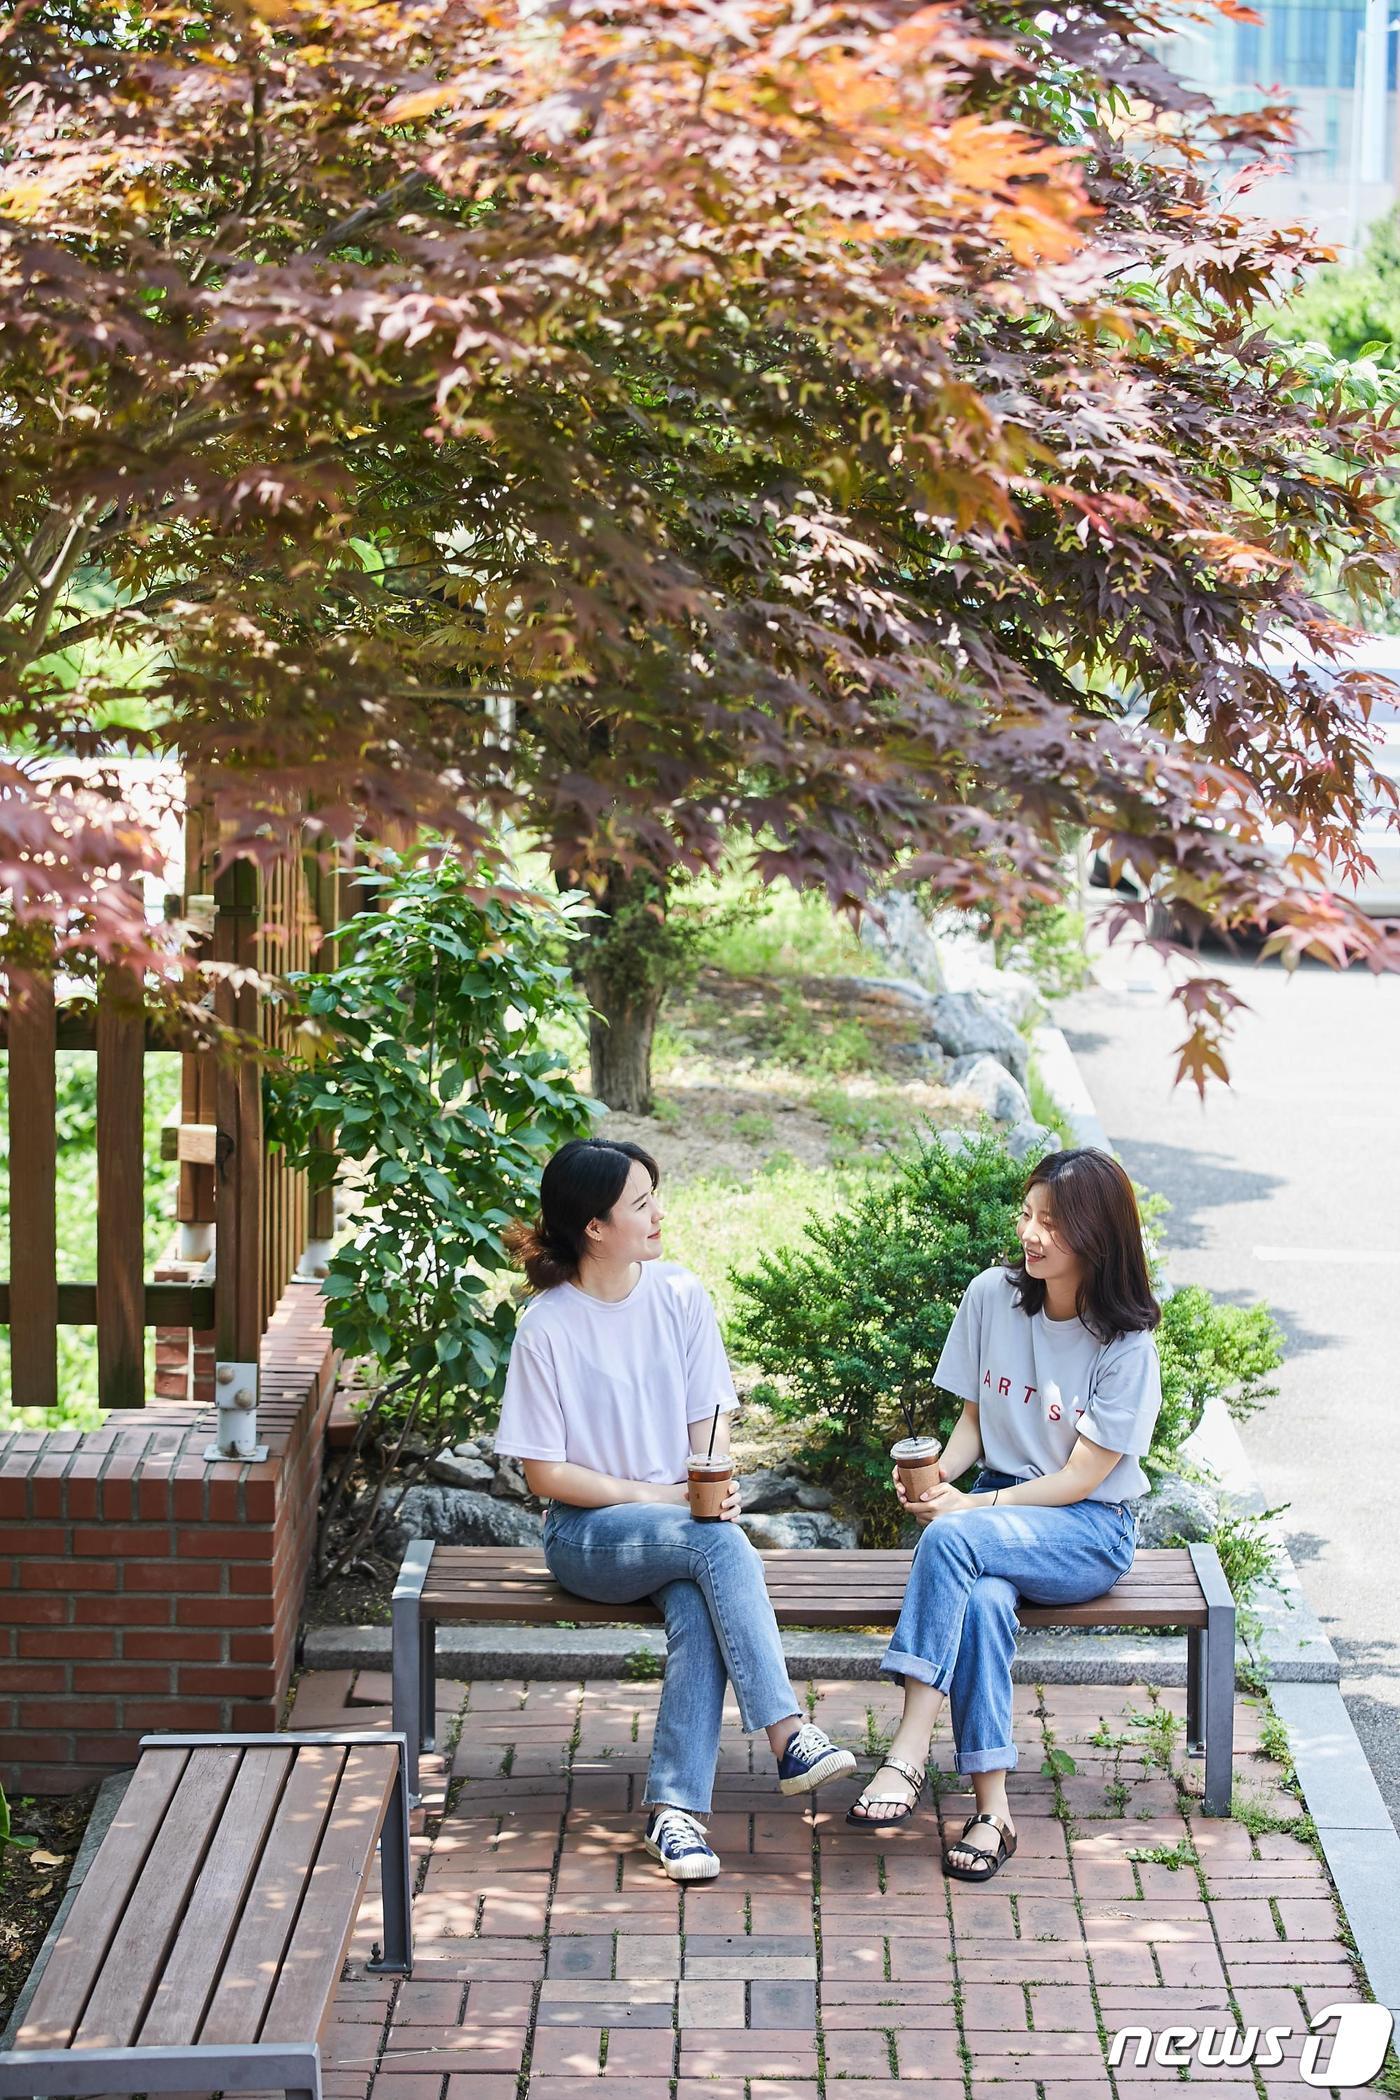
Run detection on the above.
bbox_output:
[0,809,340,1407]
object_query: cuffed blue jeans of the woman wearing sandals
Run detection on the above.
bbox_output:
[879,1472,1138,1772]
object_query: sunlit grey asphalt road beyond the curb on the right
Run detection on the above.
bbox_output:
[1056,915,1400,1829]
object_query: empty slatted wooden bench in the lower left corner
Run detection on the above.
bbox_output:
[0,1730,411,2100]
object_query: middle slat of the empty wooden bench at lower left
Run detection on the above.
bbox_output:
[141,1743,296,2048]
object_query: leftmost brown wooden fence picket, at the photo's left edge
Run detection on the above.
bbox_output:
[8,970,59,1407]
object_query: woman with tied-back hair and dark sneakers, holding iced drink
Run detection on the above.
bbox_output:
[495,1138,856,1882]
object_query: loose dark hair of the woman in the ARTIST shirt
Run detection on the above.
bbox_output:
[1007,1147,1163,1342]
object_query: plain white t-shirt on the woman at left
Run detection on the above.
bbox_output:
[495,1262,739,1483]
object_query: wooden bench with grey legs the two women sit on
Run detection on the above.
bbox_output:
[393,1539,1234,1817]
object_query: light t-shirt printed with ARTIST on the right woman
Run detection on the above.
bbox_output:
[934,1268,1163,1502]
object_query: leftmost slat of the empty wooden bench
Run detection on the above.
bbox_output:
[17,1751,187,2050]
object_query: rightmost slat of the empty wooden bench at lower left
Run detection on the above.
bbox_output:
[258,1743,399,2041]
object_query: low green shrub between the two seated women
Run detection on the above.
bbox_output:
[728,1132,1024,1544]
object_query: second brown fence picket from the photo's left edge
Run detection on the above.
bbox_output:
[97,966,145,1407]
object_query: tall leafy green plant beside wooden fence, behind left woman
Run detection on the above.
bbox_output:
[269,857,592,1573]
